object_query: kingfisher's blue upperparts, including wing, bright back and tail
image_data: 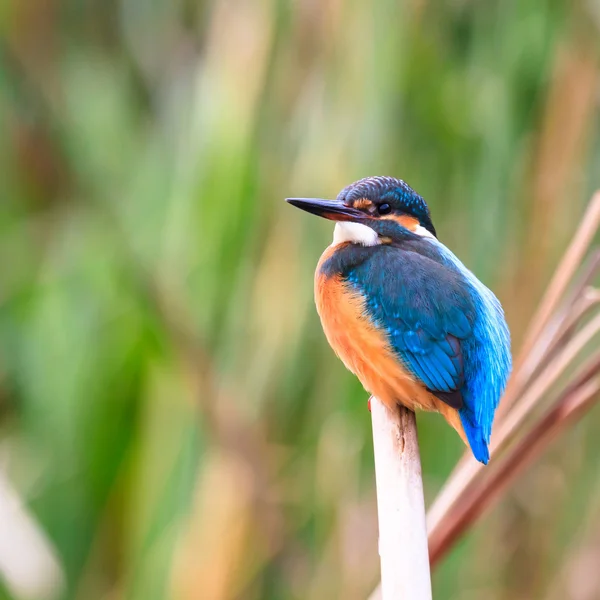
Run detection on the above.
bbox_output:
[345,238,511,463]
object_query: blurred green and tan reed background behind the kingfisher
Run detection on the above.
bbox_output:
[0,0,600,600]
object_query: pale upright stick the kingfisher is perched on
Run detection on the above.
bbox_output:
[371,398,431,600]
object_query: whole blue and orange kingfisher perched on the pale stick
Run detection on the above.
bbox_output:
[286,177,512,464]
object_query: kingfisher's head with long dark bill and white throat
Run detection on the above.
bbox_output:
[287,177,436,245]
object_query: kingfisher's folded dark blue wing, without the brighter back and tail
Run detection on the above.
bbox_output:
[348,247,475,408]
